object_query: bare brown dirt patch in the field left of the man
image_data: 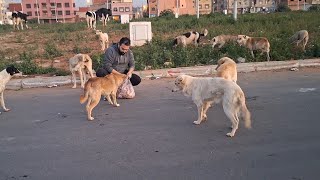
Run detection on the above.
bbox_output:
[0,28,122,70]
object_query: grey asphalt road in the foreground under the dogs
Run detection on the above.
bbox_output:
[0,68,320,180]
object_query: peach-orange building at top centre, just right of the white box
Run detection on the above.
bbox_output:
[147,0,213,17]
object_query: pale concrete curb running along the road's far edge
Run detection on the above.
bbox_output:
[6,59,320,90]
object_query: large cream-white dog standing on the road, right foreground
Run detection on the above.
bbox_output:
[172,75,251,137]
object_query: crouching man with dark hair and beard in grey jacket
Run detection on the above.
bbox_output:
[96,37,141,86]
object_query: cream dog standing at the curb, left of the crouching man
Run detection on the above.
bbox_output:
[69,54,93,88]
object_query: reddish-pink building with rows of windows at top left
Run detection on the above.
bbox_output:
[22,0,76,23]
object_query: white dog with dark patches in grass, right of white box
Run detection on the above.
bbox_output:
[173,29,208,47]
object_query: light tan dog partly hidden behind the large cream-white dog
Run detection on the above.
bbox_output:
[216,57,238,83]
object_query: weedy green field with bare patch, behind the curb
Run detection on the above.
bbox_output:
[0,10,320,74]
